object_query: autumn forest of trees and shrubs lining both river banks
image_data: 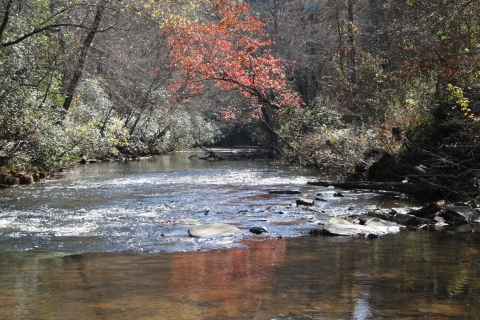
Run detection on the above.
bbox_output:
[0,0,480,201]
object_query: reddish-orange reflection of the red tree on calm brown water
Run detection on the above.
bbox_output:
[167,240,286,317]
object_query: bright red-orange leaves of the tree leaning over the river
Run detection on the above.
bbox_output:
[168,0,300,117]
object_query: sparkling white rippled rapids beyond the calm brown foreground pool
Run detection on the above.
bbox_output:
[0,153,415,253]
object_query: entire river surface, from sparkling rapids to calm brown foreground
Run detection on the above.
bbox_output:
[0,153,480,319]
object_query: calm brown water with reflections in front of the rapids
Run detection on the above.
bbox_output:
[0,231,480,319]
